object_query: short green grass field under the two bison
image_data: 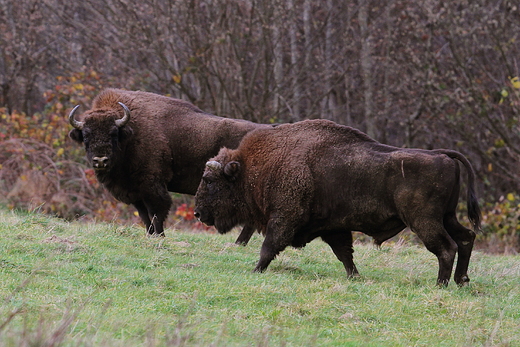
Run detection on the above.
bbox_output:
[0,210,520,347]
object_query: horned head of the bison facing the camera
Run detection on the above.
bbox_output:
[69,102,132,173]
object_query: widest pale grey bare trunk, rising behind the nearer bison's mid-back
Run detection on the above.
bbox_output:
[358,0,377,138]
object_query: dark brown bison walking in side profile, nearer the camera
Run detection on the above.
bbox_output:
[195,120,480,285]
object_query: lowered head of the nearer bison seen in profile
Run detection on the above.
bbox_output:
[195,157,246,234]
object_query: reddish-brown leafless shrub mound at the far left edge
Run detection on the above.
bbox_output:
[0,139,106,219]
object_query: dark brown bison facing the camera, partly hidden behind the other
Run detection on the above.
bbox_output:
[69,89,268,239]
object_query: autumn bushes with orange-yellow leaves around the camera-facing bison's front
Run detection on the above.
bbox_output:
[0,71,208,230]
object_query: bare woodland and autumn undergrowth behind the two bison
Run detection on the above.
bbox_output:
[0,0,520,253]
